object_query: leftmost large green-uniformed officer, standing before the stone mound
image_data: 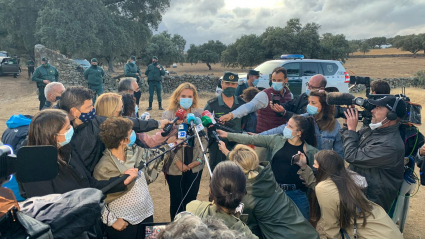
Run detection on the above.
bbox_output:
[32,58,59,110]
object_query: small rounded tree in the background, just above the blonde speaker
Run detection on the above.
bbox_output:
[187,40,227,70]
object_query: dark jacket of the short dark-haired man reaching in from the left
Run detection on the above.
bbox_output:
[69,116,158,192]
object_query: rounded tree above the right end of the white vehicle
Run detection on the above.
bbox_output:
[320,33,350,62]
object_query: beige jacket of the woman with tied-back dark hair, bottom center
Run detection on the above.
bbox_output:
[186,200,258,239]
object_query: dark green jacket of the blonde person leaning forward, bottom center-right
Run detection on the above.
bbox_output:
[242,162,319,239]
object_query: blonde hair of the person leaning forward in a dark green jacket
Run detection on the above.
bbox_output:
[229,144,260,179]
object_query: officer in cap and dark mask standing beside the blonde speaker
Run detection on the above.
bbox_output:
[205,72,249,171]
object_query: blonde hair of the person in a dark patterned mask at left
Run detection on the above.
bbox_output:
[94,93,122,118]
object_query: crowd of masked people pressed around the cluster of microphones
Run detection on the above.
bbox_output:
[2,64,425,238]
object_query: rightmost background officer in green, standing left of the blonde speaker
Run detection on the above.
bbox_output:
[145,56,165,108]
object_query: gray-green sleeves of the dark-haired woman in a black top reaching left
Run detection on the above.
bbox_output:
[227,133,319,166]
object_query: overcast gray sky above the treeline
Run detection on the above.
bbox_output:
[158,0,425,50]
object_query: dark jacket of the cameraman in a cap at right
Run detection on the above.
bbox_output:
[341,124,404,212]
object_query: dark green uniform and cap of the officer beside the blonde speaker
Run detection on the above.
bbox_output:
[204,72,249,171]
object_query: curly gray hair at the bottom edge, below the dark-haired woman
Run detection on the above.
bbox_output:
[157,212,245,239]
